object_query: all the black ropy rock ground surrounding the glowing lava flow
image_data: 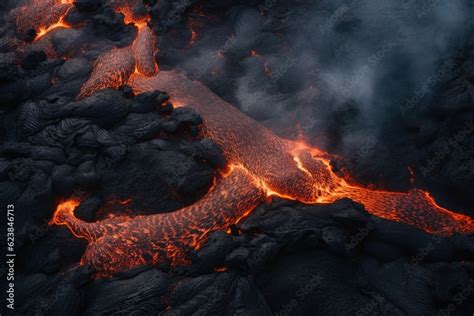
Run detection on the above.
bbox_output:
[0,0,474,316]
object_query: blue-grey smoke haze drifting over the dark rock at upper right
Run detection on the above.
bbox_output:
[167,0,470,155]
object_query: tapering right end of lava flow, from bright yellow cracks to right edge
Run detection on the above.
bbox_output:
[290,148,474,235]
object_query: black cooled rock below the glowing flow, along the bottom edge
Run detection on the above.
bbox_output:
[6,200,474,315]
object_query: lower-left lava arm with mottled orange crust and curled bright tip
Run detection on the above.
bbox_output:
[52,165,265,276]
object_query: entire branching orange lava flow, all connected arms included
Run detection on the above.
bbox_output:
[37,0,474,275]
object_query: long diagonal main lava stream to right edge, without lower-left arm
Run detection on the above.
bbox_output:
[129,71,474,235]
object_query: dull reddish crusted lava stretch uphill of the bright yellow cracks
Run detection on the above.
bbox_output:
[129,71,336,203]
